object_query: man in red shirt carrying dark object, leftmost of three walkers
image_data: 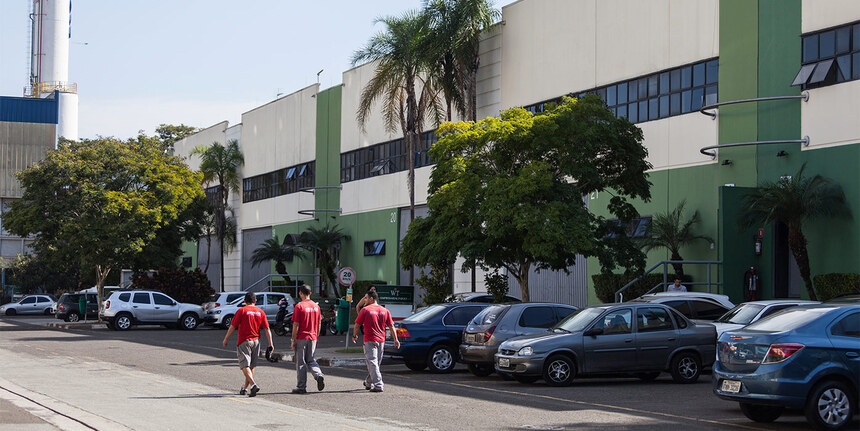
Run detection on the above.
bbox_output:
[221,292,275,397]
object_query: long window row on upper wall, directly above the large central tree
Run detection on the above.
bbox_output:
[523,59,719,123]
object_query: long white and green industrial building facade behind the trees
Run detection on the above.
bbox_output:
[171,0,860,306]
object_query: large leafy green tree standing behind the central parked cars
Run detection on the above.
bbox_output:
[401,95,650,301]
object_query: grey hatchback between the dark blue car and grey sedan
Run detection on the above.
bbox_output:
[460,302,577,376]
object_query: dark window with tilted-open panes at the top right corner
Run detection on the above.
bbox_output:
[791,21,860,90]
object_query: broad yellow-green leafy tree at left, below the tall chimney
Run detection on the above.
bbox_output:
[4,139,203,314]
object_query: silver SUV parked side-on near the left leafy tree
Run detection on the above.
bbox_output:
[99,290,203,331]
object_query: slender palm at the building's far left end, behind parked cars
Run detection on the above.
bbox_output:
[191,139,245,292]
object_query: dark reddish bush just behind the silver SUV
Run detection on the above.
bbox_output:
[132,268,215,304]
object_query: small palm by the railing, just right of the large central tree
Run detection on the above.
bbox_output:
[642,200,714,277]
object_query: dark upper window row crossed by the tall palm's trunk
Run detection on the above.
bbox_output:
[340,131,437,183]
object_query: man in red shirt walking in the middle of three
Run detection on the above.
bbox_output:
[290,284,325,394]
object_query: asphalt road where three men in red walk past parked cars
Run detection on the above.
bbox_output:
[0,317,832,431]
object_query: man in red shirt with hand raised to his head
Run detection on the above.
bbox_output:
[352,290,400,392]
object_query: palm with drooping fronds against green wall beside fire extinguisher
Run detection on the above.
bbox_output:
[740,163,851,301]
